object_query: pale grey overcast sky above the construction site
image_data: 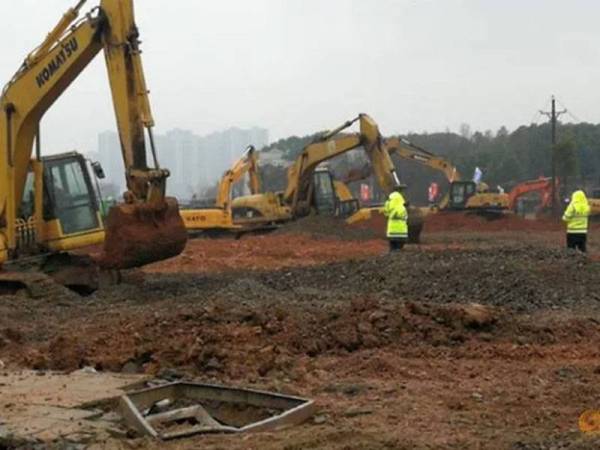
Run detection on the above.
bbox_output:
[0,0,600,152]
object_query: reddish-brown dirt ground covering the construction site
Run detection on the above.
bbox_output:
[0,215,600,450]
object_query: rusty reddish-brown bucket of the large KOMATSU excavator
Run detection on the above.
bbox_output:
[98,198,187,269]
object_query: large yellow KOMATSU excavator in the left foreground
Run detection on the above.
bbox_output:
[0,0,187,293]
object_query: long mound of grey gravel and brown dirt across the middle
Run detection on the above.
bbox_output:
[0,243,600,378]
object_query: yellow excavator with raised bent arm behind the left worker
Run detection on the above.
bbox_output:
[232,114,422,242]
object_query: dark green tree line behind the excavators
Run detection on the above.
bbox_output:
[262,119,600,203]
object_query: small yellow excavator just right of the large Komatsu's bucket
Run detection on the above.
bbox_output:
[181,145,260,233]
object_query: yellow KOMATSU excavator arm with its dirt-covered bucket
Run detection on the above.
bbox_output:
[0,0,187,268]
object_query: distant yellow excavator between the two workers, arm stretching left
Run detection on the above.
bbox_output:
[385,138,509,215]
